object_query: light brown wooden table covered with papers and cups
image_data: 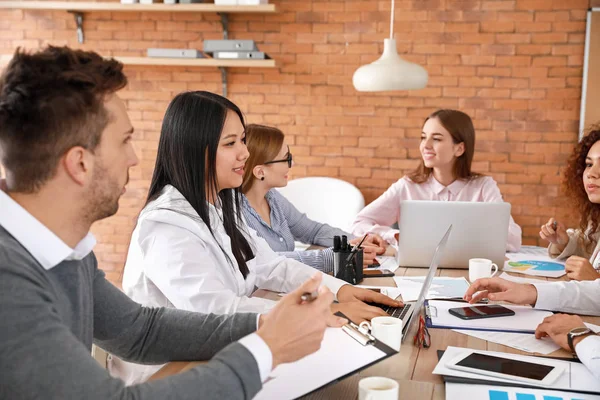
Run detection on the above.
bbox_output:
[152,268,600,400]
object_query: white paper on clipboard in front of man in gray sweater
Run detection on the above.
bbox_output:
[254,328,385,400]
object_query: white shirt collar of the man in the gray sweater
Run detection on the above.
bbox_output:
[0,190,96,270]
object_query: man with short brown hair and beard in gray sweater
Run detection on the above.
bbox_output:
[0,46,341,400]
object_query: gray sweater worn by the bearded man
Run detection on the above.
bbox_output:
[0,226,261,400]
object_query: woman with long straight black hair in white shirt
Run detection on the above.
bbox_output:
[113,91,400,383]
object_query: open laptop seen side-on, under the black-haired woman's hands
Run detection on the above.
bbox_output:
[372,225,452,342]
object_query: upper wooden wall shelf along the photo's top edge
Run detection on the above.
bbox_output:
[0,1,277,13]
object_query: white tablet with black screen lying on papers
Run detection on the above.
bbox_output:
[446,351,564,386]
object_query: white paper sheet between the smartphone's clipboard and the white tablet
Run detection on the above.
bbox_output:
[454,329,560,355]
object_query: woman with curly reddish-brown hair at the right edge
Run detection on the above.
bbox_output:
[540,127,600,281]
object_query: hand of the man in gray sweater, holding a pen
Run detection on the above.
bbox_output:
[256,273,347,368]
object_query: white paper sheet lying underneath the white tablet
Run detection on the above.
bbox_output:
[433,346,600,398]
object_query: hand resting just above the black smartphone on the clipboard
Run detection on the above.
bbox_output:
[464,278,537,305]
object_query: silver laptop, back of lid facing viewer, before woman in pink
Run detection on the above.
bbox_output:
[397,200,510,269]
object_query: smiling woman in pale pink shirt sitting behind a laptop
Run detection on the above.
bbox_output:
[352,110,521,251]
